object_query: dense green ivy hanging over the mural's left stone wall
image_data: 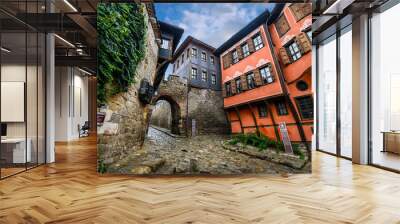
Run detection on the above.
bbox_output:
[97,3,147,104]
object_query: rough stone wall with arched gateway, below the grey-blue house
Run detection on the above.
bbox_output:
[151,76,229,136]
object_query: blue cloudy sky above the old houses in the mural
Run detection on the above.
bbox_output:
[155,3,274,78]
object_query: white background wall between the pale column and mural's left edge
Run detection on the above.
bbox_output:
[55,67,89,141]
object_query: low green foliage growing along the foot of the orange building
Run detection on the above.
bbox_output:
[228,133,305,159]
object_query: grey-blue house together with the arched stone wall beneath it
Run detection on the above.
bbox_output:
[151,36,229,137]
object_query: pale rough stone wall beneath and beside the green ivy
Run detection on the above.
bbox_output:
[97,4,158,164]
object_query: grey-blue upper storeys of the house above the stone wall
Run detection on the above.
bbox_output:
[173,36,221,90]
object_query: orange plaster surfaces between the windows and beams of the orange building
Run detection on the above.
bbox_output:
[220,7,313,141]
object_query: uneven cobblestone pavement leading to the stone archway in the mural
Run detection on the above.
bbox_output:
[110,127,309,174]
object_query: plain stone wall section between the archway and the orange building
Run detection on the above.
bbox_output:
[188,87,229,135]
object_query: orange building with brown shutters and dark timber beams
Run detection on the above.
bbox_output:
[216,4,313,142]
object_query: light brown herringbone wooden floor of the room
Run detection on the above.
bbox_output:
[0,138,400,224]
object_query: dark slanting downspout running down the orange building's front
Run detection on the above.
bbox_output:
[263,23,309,145]
